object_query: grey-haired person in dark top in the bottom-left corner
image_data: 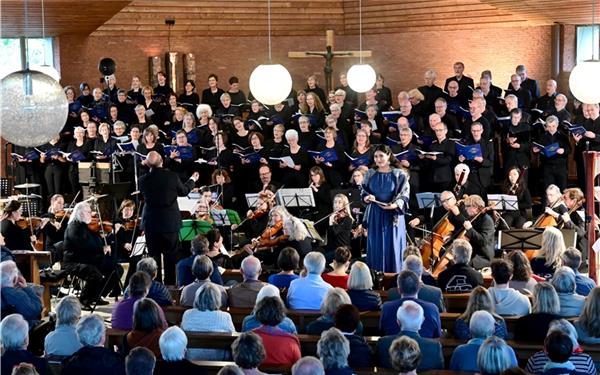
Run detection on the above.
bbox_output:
[0,314,52,375]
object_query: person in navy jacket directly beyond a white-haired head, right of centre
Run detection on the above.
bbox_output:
[379,270,442,338]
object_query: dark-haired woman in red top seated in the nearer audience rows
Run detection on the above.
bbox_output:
[252,297,302,366]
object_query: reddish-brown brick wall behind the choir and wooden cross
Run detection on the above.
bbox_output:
[58,27,551,106]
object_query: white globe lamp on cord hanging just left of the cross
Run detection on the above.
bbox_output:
[250,0,292,105]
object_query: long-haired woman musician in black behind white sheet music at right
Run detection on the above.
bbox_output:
[502,166,531,229]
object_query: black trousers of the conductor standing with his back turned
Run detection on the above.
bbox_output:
[146,231,179,285]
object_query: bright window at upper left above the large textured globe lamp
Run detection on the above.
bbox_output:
[0,38,54,77]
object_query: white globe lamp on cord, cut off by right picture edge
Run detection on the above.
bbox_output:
[569,0,600,104]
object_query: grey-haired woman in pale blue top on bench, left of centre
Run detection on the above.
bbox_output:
[181,283,235,361]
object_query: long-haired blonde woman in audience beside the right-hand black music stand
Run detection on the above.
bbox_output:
[531,227,565,280]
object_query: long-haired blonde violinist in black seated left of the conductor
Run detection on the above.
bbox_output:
[62,202,122,306]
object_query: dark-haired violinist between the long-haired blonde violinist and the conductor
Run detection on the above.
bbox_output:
[115,199,143,285]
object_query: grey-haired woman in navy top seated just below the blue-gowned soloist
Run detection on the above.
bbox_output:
[348,262,381,311]
